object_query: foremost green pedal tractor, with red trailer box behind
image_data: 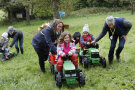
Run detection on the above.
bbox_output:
[49,55,85,88]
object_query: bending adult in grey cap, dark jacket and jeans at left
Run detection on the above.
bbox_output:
[8,26,23,54]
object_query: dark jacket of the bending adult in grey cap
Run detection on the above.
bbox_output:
[8,30,23,47]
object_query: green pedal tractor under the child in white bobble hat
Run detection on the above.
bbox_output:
[79,48,106,68]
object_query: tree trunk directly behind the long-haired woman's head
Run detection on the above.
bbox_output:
[52,0,59,19]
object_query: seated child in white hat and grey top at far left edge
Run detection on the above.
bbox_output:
[0,32,9,60]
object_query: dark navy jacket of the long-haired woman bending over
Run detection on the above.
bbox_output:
[32,23,58,53]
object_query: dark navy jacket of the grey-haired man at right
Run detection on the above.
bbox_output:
[95,17,132,42]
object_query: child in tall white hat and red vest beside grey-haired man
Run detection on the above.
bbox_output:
[81,24,99,49]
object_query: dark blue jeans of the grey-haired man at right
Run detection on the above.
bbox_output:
[108,35,125,62]
